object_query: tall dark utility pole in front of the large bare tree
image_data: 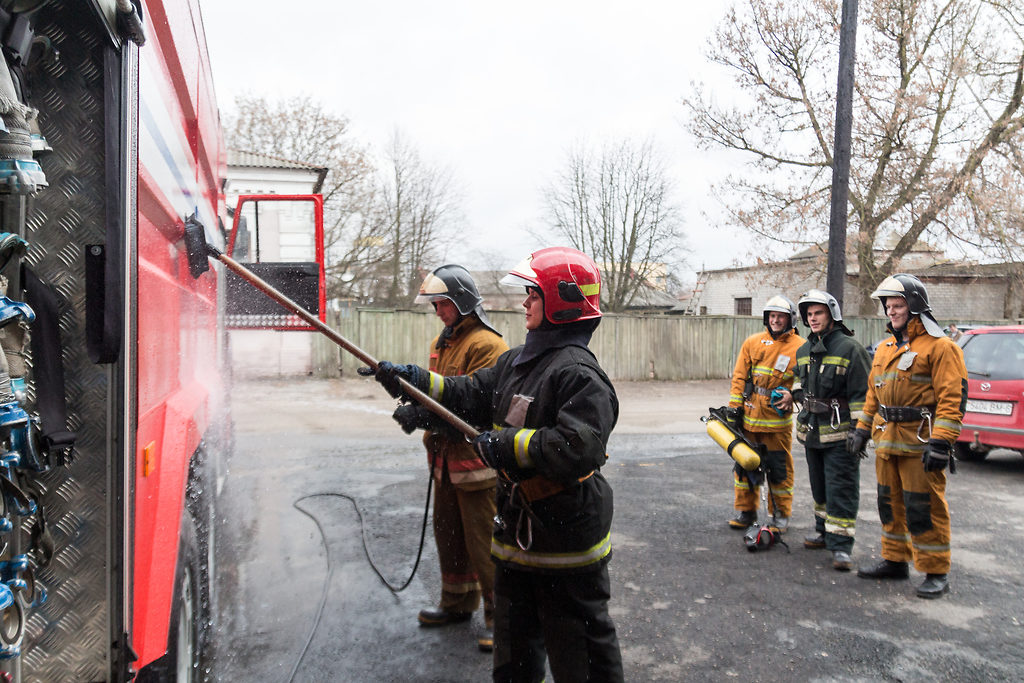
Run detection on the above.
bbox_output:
[825,0,857,307]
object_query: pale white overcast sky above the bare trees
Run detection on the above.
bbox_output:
[201,0,735,281]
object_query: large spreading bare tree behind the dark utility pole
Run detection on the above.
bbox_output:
[684,0,1024,310]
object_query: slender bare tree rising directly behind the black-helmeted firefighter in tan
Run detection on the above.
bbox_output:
[378,132,459,306]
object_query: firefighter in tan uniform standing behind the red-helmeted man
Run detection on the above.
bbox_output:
[394,265,508,651]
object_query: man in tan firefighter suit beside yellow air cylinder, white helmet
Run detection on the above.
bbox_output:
[725,295,804,531]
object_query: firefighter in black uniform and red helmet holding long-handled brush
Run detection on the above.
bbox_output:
[377,247,623,683]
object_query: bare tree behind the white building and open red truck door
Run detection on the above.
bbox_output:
[225,95,386,298]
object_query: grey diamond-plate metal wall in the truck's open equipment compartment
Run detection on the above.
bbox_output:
[22,1,110,683]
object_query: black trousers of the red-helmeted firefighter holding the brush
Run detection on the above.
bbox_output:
[494,565,623,683]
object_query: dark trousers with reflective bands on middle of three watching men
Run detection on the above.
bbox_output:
[804,442,860,553]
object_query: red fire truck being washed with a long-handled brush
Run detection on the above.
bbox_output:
[0,0,323,683]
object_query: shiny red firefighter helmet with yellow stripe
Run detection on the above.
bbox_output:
[501,247,601,325]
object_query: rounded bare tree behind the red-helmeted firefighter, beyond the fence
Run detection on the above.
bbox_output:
[544,141,682,311]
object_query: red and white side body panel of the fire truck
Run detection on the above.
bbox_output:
[131,0,225,667]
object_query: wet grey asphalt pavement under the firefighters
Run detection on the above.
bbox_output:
[209,385,1024,682]
